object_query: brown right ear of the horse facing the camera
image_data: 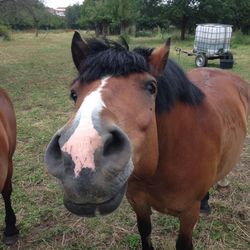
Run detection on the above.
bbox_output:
[148,38,171,77]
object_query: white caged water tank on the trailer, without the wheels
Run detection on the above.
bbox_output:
[194,24,232,55]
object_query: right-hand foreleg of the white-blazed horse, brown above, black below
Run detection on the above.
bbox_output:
[176,202,200,250]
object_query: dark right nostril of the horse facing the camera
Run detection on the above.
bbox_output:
[103,129,127,156]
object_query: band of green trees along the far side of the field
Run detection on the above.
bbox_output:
[0,0,250,39]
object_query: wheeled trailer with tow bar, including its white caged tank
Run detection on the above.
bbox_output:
[176,24,234,69]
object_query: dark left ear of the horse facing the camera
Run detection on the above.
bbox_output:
[71,31,88,71]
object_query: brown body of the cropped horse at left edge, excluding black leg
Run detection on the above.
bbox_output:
[0,89,16,191]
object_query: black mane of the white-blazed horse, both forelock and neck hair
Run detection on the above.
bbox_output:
[78,39,204,113]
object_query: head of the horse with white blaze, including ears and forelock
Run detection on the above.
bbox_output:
[45,32,170,216]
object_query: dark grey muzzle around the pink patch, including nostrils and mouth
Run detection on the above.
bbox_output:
[45,126,134,217]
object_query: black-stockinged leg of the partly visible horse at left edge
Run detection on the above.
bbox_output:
[2,161,19,245]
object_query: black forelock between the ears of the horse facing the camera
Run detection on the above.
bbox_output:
[78,39,150,83]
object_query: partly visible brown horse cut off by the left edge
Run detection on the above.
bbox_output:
[0,88,18,245]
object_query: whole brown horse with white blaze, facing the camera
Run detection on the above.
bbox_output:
[45,33,250,249]
